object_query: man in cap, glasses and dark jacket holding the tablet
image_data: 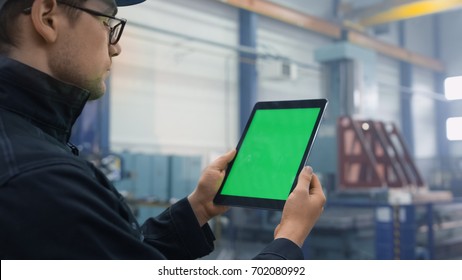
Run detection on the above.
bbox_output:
[0,0,325,259]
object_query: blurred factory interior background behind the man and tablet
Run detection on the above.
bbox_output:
[72,0,462,260]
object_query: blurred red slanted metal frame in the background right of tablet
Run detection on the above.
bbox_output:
[337,117,424,188]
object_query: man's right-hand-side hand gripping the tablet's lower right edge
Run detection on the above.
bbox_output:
[274,166,326,247]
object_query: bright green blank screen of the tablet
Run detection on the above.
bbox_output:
[221,108,320,200]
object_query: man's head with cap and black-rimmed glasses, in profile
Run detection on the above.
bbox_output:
[0,0,144,99]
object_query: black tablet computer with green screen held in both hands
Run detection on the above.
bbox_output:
[214,99,327,210]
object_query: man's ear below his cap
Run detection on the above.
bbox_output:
[30,0,59,43]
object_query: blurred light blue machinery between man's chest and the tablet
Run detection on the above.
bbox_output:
[115,152,202,222]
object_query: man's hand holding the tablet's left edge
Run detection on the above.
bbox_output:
[188,150,236,227]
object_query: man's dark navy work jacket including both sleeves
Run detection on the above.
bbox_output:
[0,56,302,259]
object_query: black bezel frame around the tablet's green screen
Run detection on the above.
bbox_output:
[213,99,328,210]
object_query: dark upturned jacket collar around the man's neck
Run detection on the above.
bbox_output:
[0,55,90,142]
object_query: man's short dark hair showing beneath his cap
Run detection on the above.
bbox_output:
[0,0,87,54]
